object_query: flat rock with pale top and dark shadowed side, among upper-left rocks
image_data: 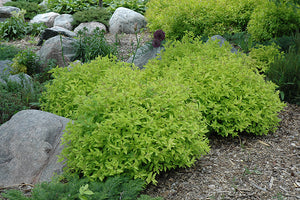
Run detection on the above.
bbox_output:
[37,26,76,46]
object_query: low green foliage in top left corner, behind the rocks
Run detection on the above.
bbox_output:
[4,1,46,19]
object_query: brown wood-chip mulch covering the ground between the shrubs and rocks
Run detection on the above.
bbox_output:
[0,33,300,200]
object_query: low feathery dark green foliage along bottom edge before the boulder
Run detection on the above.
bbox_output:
[2,176,159,200]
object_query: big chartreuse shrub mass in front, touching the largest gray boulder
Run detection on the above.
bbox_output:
[43,57,209,183]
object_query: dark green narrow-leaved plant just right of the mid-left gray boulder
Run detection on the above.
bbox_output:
[74,28,117,62]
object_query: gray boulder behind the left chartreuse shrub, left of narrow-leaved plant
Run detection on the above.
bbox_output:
[37,35,77,67]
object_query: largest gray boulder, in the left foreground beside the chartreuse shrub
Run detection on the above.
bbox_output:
[0,110,69,187]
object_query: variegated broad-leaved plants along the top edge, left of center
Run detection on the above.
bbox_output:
[47,0,98,14]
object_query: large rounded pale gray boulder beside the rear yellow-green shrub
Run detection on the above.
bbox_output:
[109,7,147,34]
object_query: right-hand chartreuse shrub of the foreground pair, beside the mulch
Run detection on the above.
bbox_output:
[145,34,284,136]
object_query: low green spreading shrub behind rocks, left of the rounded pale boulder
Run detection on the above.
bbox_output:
[72,7,111,27]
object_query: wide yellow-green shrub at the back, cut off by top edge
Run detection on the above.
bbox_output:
[145,0,263,39]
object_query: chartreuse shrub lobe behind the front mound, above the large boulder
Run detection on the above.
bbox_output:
[41,58,118,119]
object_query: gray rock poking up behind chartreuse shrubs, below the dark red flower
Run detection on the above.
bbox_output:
[127,44,164,69]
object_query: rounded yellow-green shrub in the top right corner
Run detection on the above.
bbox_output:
[247,0,300,41]
